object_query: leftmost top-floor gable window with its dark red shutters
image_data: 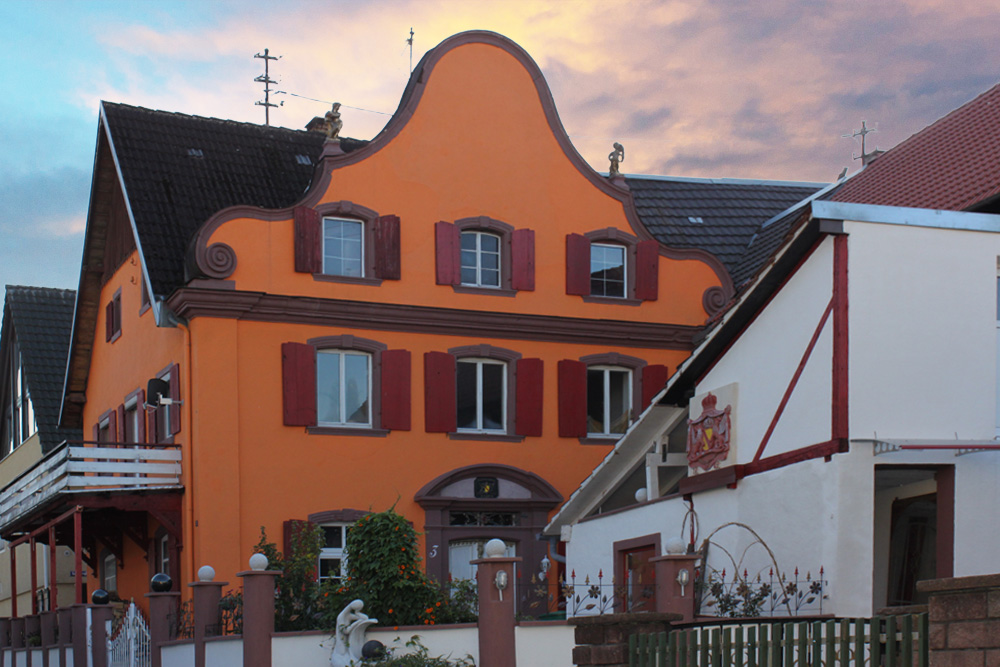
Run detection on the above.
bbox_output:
[294,201,400,285]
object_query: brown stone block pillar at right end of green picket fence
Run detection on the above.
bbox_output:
[917,574,1000,667]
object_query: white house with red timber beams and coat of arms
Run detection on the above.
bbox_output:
[545,200,1000,616]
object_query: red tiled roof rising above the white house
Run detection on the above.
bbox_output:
[831,85,1000,211]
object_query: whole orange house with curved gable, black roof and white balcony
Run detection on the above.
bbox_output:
[0,32,815,612]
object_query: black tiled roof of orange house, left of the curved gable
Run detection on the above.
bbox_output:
[102,102,366,295]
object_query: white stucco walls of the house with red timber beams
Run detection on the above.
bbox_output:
[565,205,1000,616]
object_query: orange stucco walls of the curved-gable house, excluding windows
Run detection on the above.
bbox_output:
[74,32,726,612]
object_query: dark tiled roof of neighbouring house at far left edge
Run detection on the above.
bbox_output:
[4,285,82,452]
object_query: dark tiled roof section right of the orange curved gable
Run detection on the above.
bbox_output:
[625,176,824,278]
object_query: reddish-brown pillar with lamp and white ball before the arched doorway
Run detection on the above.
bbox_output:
[472,540,521,667]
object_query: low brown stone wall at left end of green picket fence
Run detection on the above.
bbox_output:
[567,612,680,667]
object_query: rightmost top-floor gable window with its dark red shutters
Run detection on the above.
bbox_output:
[566,227,660,305]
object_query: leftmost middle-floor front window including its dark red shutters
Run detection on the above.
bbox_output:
[281,335,410,436]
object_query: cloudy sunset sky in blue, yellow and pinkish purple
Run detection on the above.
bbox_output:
[0,0,1000,316]
